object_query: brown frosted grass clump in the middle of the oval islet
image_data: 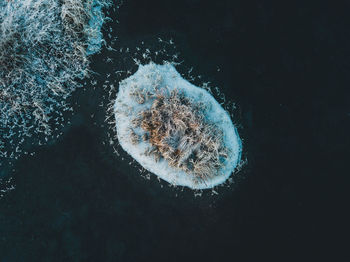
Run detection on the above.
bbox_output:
[132,89,228,181]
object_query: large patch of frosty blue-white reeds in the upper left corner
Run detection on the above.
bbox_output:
[0,0,112,166]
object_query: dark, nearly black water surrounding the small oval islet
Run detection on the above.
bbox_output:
[0,0,350,262]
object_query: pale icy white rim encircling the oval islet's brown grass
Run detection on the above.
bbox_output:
[114,63,242,189]
